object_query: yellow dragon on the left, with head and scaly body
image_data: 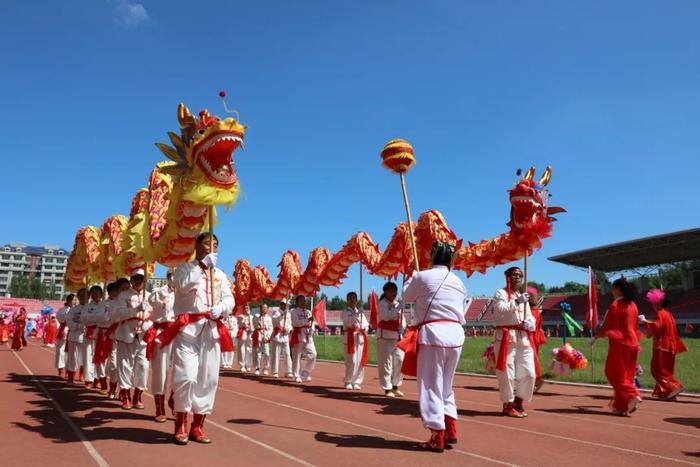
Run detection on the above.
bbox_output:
[65,104,245,290]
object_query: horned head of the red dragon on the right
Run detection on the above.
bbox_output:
[508,167,565,231]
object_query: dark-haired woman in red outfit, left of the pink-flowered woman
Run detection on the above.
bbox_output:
[589,277,642,416]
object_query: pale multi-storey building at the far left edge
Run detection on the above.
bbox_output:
[0,242,68,298]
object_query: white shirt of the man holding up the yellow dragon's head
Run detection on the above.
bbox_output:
[173,260,235,339]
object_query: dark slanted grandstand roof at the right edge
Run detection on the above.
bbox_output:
[549,228,700,272]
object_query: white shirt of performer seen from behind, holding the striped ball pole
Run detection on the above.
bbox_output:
[403,266,467,347]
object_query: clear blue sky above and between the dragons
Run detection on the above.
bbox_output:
[0,0,700,295]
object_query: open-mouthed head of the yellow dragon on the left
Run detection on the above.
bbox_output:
[156,104,246,204]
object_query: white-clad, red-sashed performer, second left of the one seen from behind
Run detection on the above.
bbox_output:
[343,292,369,391]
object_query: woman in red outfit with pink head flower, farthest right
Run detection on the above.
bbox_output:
[639,289,687,399]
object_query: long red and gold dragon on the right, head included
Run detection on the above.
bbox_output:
[233,168,564,306]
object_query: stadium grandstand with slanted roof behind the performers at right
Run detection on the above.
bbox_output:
[465,228,700,337]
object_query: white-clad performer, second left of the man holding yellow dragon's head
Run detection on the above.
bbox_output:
[114,269,153,410]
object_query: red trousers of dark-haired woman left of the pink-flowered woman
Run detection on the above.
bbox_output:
[605,340,639,412]
